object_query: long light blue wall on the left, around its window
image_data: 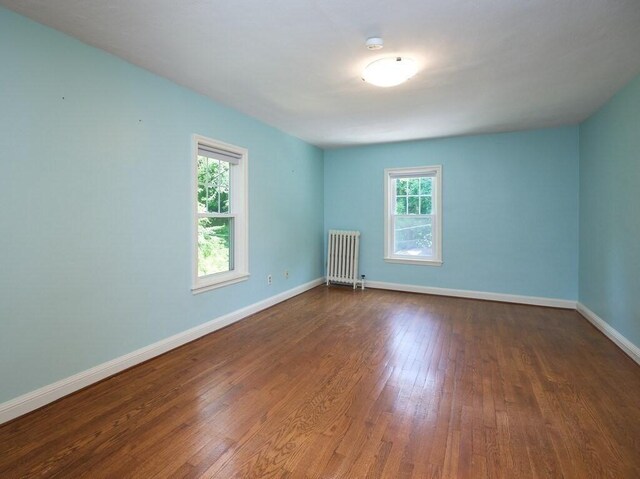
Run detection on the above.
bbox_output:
[0,8,323,402]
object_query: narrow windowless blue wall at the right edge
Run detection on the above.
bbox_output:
[580,76,640,347]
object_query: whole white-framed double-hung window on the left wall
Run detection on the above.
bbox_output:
[192,135,249,292]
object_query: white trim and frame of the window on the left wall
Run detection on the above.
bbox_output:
[191,135,249,294]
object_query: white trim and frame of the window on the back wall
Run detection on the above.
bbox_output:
[384,165,442,266]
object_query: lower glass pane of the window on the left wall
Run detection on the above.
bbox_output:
[198,218,233,276]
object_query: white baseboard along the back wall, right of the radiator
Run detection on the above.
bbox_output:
[365,280,576,309]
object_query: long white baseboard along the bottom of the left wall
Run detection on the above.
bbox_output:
[0,278,324,424]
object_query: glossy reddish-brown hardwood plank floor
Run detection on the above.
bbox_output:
[0,286,640,479]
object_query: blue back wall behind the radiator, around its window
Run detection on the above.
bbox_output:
[324,127,578,300]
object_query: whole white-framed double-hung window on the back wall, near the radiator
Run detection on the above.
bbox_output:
[384,166,442,266]
